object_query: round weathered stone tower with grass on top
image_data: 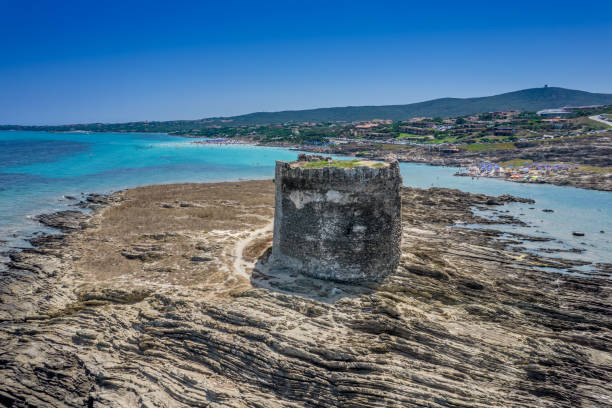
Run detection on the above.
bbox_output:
[271,155,402,282]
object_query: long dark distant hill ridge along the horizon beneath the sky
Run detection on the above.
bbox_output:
[0,87,612,132]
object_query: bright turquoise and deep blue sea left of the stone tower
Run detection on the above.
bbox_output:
[0,132,297,250]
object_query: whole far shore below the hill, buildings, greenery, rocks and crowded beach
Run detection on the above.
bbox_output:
[165,105,612,191]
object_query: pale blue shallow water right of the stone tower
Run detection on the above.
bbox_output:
[400,163,612,270]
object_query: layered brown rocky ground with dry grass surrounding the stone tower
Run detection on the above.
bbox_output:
[0,180,612,407]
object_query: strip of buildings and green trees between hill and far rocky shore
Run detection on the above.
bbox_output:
[170,105,612,147]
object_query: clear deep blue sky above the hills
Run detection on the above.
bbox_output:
[0,0,612,124]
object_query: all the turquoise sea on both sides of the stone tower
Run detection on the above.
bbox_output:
[0,131,612,272]
